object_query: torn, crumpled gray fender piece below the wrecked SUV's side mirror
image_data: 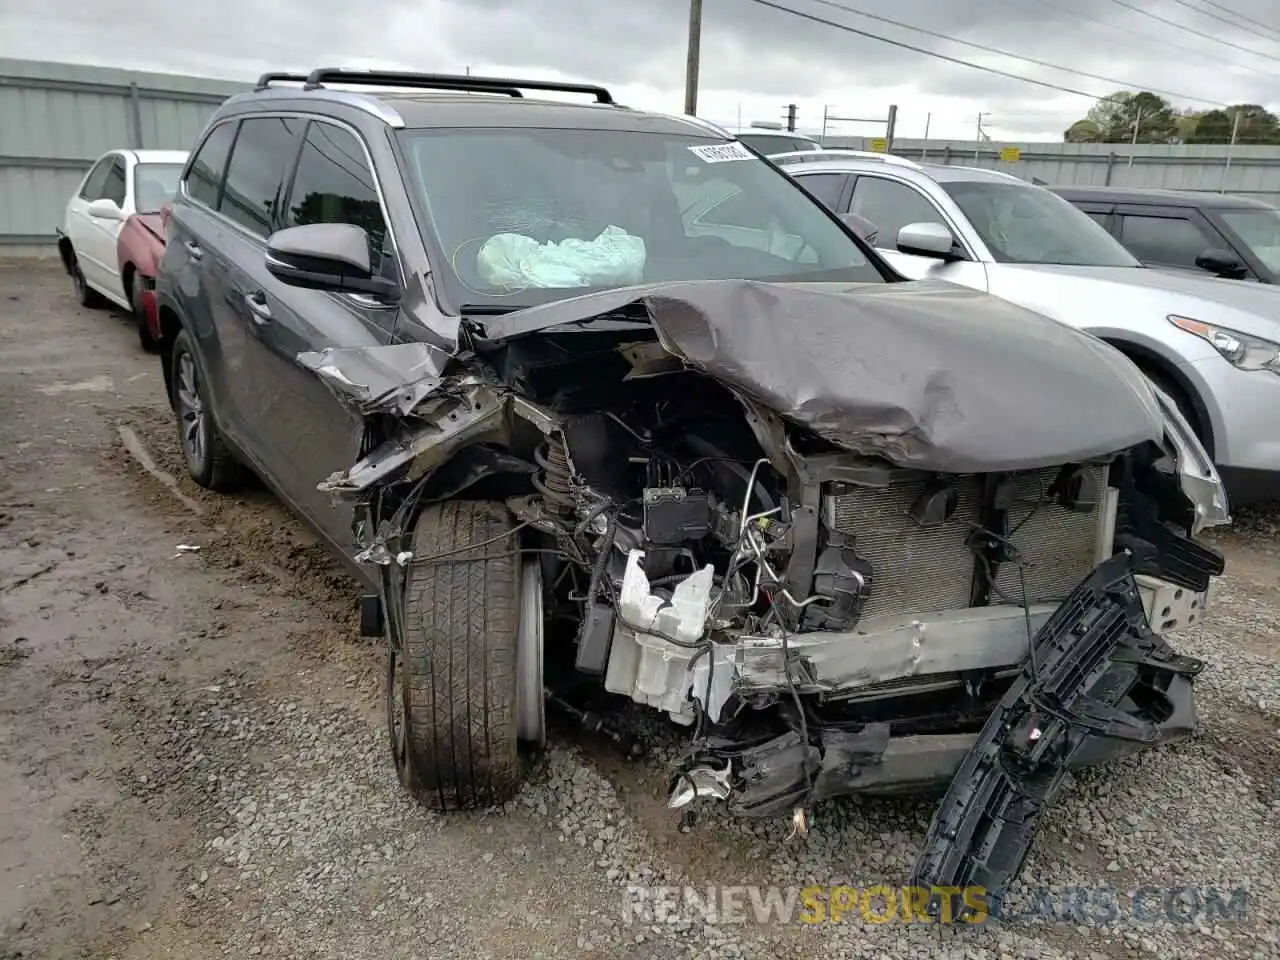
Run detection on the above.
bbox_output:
[297,342,449,416]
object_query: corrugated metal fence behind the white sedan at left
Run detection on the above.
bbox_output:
[0,58,248,256]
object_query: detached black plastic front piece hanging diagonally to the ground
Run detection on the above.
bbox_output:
[913,553,1204,916]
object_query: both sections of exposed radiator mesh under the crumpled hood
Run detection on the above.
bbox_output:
[827,466,1106,617]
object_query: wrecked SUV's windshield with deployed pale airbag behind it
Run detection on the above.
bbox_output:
[401,128,883,308]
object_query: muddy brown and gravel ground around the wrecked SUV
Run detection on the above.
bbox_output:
[0,268,1280,960]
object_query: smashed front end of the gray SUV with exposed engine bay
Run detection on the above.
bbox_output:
[300,280,1226,911]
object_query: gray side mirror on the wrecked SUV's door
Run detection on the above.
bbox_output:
[266,223,399,300]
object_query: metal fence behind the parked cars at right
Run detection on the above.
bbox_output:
[827,137,1280,205]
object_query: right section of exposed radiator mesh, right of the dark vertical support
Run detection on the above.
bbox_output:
[996,465,1107,604]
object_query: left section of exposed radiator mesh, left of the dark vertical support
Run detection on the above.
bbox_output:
[832,477,979,617]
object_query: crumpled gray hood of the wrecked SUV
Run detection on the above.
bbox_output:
[485,280,1164,472]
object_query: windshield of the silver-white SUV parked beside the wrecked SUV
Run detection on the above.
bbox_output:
[942,180,1140,266]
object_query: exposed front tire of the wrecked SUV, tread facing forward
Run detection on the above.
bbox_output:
[388,500,521,810]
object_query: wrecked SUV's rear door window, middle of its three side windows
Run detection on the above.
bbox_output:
[218,116,303,237]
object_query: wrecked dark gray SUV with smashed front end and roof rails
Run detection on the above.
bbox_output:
[157,70,1226,906]
